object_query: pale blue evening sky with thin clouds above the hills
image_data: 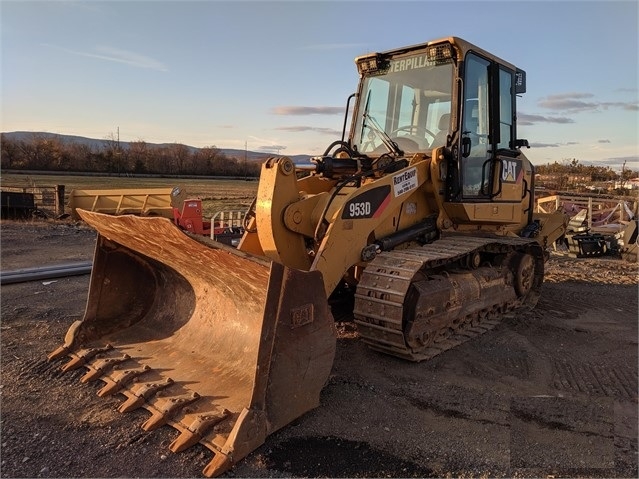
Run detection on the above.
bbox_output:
[0,0,639,171]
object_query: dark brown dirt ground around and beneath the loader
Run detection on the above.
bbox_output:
[0,222,639,477]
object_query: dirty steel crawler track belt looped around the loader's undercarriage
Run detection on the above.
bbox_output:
[353,236,543,361]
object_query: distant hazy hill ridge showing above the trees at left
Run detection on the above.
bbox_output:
[2,131,311,164]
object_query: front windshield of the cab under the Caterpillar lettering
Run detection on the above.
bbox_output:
[352,53,453,156]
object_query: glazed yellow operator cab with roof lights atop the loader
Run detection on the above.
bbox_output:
[349,37,531,209]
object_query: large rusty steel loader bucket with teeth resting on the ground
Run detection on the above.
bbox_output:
[49,210,336,477]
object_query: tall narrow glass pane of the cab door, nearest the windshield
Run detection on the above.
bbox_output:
[461,53,490,197]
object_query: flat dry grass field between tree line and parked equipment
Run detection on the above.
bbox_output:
[0,173,257,218]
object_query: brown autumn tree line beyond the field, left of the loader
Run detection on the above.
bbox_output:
[0,133,261,177]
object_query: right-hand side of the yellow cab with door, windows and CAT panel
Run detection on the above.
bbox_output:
[449,52,532,223]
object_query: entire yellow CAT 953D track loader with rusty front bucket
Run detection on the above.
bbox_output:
[49,37,567,476]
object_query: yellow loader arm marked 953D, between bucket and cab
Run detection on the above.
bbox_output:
[240,157,430,298]
